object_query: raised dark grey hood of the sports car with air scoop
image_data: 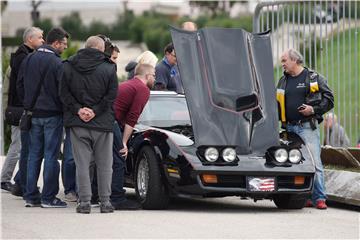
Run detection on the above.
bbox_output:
[170,28,279,154]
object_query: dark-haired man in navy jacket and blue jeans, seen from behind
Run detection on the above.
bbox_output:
[17,28,69,208]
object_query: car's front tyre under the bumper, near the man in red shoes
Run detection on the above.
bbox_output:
[274,194,307,209]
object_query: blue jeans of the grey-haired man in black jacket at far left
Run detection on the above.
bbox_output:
[14,131,30,195]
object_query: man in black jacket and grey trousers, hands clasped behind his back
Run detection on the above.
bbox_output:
[60,36,117,213]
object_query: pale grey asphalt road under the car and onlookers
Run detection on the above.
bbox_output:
[0,158,360,239]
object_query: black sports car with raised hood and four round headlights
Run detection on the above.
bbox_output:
[126,28,315,209]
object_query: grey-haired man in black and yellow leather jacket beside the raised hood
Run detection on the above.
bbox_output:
[276,49,334,209]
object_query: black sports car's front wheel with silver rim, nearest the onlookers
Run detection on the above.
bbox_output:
[135,146,169,209]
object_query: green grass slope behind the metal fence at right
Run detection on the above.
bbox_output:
[317,29,360,146]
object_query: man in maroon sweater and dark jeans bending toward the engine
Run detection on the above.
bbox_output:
[111,64,155,210]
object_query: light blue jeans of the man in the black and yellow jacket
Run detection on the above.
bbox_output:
[287,122,326,204]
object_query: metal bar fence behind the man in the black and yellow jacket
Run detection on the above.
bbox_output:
[253,0,360,146]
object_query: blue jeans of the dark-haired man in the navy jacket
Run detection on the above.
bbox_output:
[25,115,63,201]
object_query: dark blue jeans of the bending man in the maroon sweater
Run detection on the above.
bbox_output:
[110,122,126,204]
